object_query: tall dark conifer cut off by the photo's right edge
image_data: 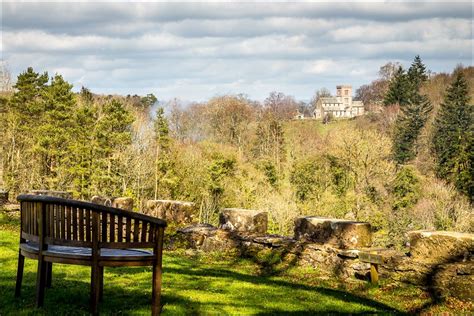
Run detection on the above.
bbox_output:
[432,70,474,202]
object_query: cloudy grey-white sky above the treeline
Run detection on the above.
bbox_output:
[1,1,474,100]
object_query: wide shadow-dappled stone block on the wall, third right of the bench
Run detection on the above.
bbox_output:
[294,216,372,249]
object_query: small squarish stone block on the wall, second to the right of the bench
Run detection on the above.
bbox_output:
[219,208,268,234]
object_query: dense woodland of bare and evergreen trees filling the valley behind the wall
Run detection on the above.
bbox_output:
[0,56,474,247]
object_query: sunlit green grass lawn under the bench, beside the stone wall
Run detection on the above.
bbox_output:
[0,212,468,315]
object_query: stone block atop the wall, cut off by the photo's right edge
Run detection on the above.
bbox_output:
[408,230,474,264]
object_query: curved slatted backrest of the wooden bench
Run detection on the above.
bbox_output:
[17,195,166,249]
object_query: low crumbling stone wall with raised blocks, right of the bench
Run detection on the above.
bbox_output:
[168,209,474,300]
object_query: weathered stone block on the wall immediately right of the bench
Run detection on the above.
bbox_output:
[144,200,198,225]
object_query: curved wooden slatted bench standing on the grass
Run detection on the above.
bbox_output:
[15,195,166,315]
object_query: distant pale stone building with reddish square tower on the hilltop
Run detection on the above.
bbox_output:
[295,85,364,119]
